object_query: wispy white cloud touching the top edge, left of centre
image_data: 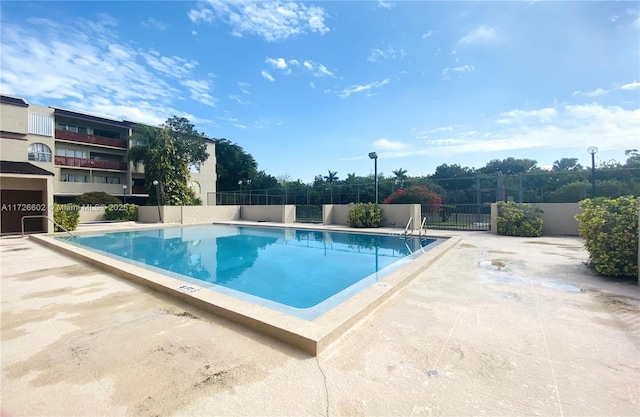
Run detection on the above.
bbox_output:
[188,0,329,42]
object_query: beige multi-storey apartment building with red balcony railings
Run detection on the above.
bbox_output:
[0,95,216,234]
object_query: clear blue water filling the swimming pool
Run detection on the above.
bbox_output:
[57,225,437,319]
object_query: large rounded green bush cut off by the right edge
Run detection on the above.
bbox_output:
[576,196,640,277]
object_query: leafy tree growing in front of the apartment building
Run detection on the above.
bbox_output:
[127,116,209,206]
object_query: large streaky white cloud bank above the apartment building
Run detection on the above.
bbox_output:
[0,15,216,124]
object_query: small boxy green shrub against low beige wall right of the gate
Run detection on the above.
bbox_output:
[497,201,542,237]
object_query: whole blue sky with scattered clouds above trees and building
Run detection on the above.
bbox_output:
[0,0,640,182]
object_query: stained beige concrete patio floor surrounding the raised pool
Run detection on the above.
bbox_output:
[0,226,640,416]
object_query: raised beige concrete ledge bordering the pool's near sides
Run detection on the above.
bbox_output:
[31,226,460,355]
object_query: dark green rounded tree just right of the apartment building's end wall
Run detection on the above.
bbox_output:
[216,138,258,191]
